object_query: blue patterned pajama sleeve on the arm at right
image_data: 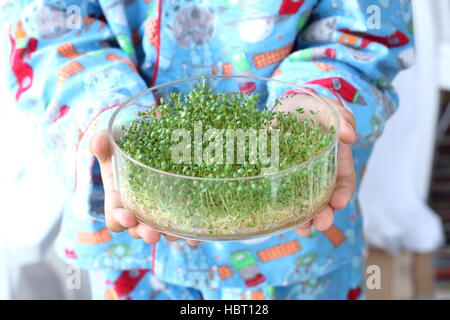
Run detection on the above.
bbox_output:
[271,0,414,148]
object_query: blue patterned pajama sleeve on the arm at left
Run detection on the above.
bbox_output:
[1,0,153,217]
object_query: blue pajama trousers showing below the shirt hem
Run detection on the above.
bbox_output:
[90,257,364,300]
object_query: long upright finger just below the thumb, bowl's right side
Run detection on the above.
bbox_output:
[330,143,356,210]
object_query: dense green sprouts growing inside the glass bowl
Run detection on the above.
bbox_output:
[115,81,336,239]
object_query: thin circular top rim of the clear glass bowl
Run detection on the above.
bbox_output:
[107,75,341,181]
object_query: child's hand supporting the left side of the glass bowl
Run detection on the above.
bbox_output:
[89,131,198,245]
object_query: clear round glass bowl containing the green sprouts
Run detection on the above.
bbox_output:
[108,76,339,241]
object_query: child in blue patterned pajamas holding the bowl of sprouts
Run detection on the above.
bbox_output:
[2,0,412,299]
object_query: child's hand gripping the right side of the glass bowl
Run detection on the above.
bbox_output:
[276,96,356,237]
